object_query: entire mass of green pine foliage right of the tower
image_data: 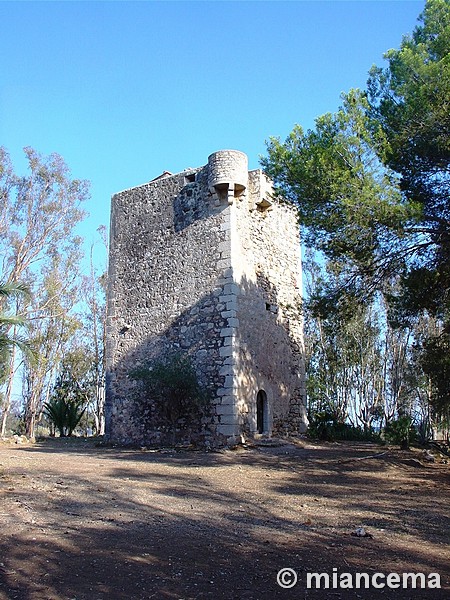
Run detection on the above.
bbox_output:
[262,0,450,418]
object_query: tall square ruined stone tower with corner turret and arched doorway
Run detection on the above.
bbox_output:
[106,150,307,446]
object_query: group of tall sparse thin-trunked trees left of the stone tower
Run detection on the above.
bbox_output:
[0,148,104,437]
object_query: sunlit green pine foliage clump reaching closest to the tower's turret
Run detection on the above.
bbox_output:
[262,90,416,298]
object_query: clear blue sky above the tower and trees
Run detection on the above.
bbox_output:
[0,0,425,262]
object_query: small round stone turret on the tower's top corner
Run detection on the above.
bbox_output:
[208,150,248,196]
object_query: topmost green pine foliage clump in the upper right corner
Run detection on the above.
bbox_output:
[368,0,450,216]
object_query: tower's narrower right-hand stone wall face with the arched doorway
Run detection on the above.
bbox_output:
[223,170,307,435]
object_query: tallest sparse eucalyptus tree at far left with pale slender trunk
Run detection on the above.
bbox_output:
[0,148,89,435]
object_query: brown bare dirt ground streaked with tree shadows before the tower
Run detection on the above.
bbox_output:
[0,439,450,600]
